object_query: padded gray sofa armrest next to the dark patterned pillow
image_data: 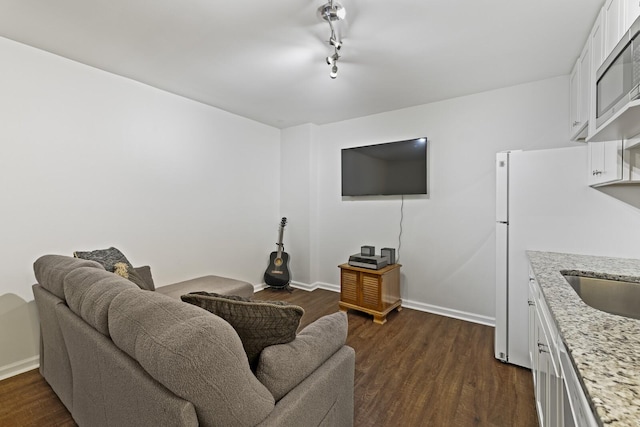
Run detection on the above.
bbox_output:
[256,312,348,401]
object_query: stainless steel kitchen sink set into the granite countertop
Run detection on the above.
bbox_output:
[564,275,640,319]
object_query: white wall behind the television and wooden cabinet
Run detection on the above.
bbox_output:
[282,77,586,324]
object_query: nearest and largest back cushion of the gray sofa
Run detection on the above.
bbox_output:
[109,289,275,426]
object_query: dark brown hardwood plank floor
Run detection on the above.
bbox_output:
[0,289,538,427]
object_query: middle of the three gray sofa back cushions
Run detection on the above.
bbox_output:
[63,267,142,336]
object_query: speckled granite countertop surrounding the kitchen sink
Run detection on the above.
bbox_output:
[527,251,640,426]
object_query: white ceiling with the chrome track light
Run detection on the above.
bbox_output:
[0,0,603,128]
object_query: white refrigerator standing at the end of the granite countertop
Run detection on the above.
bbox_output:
[495,145,616,367]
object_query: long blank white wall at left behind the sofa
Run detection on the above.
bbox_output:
[0,38,280,377]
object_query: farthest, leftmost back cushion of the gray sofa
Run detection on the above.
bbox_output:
[33,255,104,300]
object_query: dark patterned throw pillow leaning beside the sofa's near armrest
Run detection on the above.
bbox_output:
[180,292,304,371]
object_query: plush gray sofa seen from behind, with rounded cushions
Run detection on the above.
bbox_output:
[33,255,355,427]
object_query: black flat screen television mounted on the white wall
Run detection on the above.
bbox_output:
[342,138,427,196]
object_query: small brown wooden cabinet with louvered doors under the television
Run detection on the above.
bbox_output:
[338,264,402,325]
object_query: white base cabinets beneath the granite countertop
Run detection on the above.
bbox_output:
[529,270,597,427]
